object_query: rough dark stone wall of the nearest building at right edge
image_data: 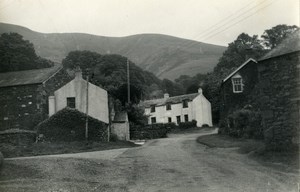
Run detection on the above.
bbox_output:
[256,52,300,150]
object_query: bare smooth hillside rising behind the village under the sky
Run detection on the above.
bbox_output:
[0,23,226,80]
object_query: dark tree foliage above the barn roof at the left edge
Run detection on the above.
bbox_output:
[0,33,53,72]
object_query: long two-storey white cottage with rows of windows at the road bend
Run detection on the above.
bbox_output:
[141,88,212,127]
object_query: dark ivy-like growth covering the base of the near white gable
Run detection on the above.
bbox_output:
[37,108,107,141]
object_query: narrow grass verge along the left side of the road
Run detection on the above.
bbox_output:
[0,141,139,158]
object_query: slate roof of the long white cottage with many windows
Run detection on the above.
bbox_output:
[140,93,199,107]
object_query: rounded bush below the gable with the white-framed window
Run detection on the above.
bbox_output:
[220,106,263,139]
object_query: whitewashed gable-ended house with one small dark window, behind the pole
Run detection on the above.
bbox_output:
[48,70,109,124]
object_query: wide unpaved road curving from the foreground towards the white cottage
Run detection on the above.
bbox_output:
[0,132,299,192]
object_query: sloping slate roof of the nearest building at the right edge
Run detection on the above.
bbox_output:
[258,30,300,61]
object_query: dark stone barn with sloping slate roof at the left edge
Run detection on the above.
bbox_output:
[0,65,71,131]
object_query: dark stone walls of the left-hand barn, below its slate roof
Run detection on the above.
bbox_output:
[0,67,71,131]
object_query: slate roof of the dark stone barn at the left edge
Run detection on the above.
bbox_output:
[0,65,62,87]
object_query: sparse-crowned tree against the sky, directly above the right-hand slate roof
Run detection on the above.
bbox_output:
[261,25,299,49]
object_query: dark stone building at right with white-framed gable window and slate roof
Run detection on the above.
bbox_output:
[221,31,300,148]
